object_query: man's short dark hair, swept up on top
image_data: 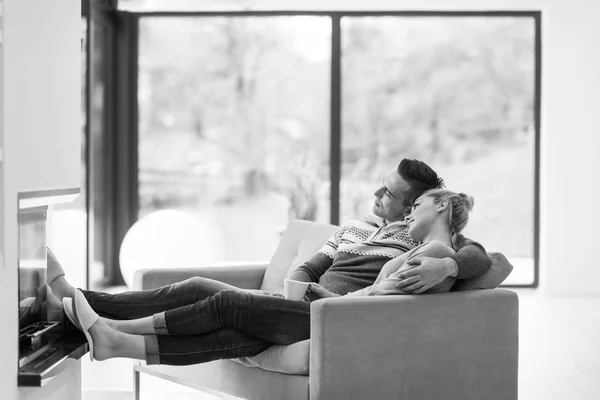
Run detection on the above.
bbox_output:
[397,158,444,206]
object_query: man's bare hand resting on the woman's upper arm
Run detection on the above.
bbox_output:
[396,257,458,294]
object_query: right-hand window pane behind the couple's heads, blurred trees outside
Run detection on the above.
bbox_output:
[340,17,535,284]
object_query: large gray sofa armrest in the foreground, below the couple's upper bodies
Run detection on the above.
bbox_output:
[310,289,518,400]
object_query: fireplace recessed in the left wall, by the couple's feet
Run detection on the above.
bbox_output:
[17,189,87,386]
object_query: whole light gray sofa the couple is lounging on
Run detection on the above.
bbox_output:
[134,221,518,400]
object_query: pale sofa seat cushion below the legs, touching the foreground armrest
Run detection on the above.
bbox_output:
[233,339,310,376]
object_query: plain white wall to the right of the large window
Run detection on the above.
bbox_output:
[540,0,600,296]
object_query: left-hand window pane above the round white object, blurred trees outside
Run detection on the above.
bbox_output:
[138,17,331,262]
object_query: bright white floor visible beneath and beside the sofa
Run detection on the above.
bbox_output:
[82,290,600,400]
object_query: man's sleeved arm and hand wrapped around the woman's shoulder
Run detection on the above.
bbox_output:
[397,235,492,294]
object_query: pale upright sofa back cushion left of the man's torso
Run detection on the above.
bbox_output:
[260,220,337,293]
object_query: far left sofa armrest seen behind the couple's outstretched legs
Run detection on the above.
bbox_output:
[133,262,269,290]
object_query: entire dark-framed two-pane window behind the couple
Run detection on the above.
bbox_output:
[130,12,540,285]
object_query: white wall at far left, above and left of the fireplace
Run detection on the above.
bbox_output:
[0,0,81,400]
